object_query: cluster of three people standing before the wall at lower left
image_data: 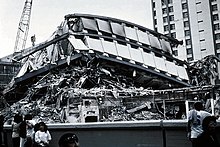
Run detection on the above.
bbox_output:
[12,114,52,147]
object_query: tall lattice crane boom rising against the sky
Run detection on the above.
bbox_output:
[14,0,32,53]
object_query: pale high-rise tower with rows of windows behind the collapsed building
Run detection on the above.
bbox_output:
[152,0,220,62]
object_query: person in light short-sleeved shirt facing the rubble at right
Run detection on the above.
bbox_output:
[187,102,211,147]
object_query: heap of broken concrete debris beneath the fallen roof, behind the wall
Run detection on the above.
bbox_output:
[2,55,220,124]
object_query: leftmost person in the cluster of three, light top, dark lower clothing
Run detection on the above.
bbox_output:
[12,114,22,147]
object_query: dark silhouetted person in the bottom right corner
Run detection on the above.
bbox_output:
[196,116,220,147]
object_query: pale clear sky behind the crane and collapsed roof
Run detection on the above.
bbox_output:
[0,0,153,57]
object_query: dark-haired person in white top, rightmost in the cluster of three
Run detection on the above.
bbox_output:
[34,122,52,147]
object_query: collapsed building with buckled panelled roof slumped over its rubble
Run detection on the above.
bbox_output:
[2,14,217,123]
